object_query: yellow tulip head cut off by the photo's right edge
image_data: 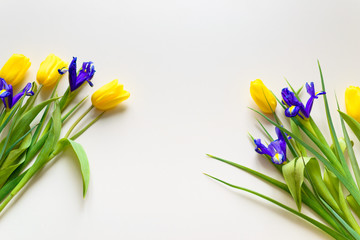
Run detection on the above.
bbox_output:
[345,86,360,122]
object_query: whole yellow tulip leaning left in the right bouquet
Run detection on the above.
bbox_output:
[250,79,277,113]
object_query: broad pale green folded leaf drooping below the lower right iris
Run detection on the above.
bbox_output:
[282,157,310,212]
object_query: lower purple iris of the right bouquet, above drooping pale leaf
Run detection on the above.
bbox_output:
[254,128,286,165]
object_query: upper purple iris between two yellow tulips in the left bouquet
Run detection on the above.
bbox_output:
[68,57,95,91]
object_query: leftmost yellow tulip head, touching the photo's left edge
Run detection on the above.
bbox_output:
[0,54,31,86]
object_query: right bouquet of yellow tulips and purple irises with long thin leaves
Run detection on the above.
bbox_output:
[206,63,360,239]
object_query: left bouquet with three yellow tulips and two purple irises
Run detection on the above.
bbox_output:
[0,54,130,212]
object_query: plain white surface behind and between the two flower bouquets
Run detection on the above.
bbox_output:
[0,0,360,240]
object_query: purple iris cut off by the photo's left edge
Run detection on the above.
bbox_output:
[0,78,34,109]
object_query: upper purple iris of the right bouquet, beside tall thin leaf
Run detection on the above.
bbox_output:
[281,82,325,118]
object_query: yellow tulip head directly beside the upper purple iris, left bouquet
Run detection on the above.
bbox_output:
[36,54,68,87]
